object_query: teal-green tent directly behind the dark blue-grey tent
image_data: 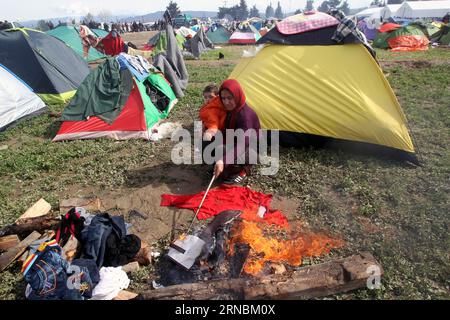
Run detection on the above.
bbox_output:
[46,26,105,62]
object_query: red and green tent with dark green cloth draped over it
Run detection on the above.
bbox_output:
[53,58,178,141]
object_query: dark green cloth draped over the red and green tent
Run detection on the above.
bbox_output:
[61,57,132,124]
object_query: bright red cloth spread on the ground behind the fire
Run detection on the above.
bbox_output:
[161,184,288,227]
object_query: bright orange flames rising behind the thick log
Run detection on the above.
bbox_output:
[228,220,343,275]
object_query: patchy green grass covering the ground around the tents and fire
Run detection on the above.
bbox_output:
[0,47,450,299]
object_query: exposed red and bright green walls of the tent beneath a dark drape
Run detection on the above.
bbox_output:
[53,70,177,141]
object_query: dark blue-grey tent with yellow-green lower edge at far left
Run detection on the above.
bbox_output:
[0,29,89,103]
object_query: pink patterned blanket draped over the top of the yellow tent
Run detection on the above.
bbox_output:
[276,11,339,35]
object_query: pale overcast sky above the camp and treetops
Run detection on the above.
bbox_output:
[0,0,371,21]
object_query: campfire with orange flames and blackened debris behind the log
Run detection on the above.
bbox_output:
[157,209,343,286]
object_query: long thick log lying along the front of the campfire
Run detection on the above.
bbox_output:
[138,253,383,300]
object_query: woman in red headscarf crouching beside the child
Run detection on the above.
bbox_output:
[203,79,261,184]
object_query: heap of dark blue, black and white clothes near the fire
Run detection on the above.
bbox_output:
[22,207,141,300]
